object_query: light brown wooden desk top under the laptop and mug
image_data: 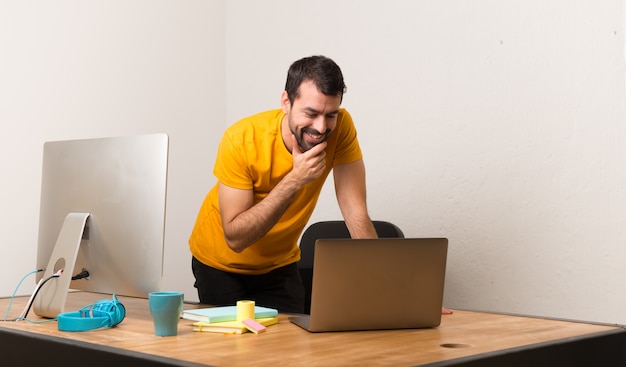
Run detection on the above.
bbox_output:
[0,292,625,367]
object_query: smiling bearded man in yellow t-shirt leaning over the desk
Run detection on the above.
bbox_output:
[189,56,376,312]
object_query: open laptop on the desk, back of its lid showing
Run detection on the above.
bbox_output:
[289,238,448,332]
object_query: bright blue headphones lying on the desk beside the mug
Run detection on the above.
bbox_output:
[57,295,126,331]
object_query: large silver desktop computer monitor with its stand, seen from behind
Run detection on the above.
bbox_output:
[33,134,169,318]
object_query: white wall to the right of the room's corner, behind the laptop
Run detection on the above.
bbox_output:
[227,0,626,323]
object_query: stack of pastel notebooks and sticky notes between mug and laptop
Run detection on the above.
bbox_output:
[181,306,278,334]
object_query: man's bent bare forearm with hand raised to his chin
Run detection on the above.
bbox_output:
[218,137,327,252]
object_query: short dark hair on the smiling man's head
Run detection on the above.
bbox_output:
[285,56,346,104]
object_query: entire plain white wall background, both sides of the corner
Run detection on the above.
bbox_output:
[0,0,626,324]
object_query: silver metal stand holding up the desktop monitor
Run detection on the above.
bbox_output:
[33,213,90,318]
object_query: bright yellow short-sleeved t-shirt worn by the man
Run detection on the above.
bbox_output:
[189,108,362,274]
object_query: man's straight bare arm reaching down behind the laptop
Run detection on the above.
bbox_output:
[333,159,378,238]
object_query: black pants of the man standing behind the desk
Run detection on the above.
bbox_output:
[191,257,304,313]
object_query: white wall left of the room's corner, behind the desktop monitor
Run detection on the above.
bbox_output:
[0,0,226,304]
